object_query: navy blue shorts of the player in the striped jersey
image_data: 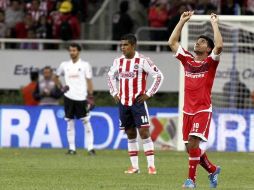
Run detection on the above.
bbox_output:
[119,103,150,129]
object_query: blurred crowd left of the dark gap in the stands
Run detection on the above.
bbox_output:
[0,0,101,49]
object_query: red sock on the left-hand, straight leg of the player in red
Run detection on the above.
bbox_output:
[188,148,201,182]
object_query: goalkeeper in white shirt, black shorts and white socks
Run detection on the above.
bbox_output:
[56,43,95,155]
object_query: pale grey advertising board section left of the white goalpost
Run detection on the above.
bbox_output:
[0,50,179,92]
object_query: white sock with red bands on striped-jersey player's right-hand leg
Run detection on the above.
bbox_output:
[143,137,155,167]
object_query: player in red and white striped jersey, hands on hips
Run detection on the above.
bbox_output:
[107,34,163,174]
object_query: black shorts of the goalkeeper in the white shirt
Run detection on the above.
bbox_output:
[64,96,88,119]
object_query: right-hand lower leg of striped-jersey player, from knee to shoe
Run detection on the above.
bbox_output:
[138,127,157,174]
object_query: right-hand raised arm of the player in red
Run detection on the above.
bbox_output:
[210,13,223,55]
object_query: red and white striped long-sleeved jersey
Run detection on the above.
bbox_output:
[107,52,163,106]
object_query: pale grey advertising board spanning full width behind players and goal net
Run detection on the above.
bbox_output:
[0,50,254,92]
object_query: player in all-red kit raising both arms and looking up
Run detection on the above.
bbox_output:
[168,11,223,188]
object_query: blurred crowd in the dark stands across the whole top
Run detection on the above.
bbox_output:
[0,0,254,49]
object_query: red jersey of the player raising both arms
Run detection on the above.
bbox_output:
[176,46,220,115]
